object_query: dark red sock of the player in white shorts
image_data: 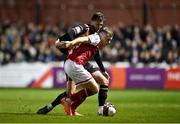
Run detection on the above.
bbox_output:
[71,89,88,110]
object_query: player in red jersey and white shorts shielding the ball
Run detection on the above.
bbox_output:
[59,27,113,115]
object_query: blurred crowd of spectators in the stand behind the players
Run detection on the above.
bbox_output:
[0,20,180,65]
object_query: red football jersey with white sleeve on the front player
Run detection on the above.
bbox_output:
[68,34,100,65]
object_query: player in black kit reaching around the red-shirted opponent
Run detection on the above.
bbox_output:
[37,12,109,114]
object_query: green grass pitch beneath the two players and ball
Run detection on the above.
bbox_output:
[0,89,180,123]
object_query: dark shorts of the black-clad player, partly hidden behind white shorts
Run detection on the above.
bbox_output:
[66,62,98,81]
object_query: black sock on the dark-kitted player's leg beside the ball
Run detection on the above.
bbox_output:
[98,85,108,106]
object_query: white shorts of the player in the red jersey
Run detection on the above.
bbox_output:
[64,59,92,85]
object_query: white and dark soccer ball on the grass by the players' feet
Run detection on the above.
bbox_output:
[103,103,116,116]
